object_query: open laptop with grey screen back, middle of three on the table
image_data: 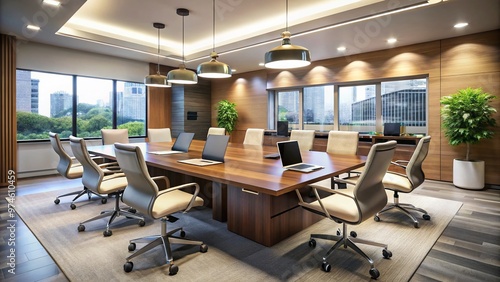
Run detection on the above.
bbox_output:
[178,134,229,166]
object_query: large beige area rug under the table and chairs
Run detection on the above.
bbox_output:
[16,188,462,281]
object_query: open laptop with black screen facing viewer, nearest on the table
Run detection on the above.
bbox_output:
[276,140,323,172]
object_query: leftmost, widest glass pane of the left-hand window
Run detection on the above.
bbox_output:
[16,70,73,140]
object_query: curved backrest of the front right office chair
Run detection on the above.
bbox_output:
[354,140,397,223]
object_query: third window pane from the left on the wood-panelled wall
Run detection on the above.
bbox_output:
[339,84,377,132]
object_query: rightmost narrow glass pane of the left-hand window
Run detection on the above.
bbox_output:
[116,81,146,136]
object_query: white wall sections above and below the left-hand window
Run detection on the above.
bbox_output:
[16,42,149,178]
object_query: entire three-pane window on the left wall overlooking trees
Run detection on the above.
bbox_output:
[16,70,146,141]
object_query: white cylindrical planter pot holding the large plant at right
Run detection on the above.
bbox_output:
[453,159,484,190]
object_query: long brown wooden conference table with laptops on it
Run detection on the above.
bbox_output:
[88,140,366,246]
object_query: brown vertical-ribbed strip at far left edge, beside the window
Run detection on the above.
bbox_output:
[0,34,17,187]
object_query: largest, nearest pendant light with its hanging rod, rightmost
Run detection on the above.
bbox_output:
[264,0,311,69]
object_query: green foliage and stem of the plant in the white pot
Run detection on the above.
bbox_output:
[441,87,496,161]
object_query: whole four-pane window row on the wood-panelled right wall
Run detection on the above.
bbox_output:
[270,78,427,134]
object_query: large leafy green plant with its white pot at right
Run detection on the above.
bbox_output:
[441,87,496,189]
